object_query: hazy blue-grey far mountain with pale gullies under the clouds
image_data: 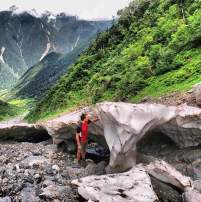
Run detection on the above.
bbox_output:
[0,11,109,88]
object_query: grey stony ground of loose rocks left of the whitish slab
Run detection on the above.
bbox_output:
[0,142,106,202]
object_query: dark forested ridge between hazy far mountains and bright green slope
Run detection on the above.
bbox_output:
[11,40,93,99]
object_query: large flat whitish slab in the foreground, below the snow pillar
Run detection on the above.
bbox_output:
[72,166,158,202]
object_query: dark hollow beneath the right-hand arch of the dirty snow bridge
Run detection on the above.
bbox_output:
[136,130,201,180]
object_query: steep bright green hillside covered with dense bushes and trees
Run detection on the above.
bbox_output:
[27,0,201,121]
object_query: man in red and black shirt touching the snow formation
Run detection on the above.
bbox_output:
[76,113,98,164]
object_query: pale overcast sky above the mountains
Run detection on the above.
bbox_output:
[0,0,132,19]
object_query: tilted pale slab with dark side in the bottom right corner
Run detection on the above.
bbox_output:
[145,161,201,202]
